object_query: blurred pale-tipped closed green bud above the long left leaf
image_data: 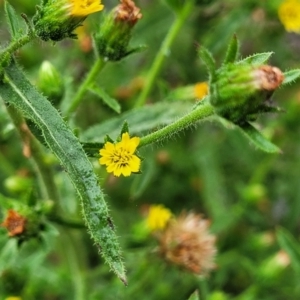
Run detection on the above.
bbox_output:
[38,61,64,102]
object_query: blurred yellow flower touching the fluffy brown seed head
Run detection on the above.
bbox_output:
[146,205,172,231]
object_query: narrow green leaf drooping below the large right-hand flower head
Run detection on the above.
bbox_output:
[239,123,281,153]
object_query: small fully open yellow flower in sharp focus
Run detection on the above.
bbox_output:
[99,132,141,177]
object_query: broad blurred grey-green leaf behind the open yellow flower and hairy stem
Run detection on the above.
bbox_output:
[81,101,191,142]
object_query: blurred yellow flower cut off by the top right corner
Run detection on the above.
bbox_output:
[278,0,300,33]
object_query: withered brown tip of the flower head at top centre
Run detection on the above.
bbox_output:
[115,0,142,26]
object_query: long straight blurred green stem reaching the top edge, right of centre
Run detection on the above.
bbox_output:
[135,0,194,107]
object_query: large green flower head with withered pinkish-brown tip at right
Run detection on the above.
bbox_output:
[210,63,284,124]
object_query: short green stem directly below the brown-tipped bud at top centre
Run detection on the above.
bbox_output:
[66,57,105,119]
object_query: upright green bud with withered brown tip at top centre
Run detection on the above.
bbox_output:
[94,0,142,61]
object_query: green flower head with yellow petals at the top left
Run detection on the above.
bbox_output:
[33,0,103,41]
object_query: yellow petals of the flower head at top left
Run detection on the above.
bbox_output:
[70,0,104,17]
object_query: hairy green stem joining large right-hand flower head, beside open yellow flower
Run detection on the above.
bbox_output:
[139,102,214,147]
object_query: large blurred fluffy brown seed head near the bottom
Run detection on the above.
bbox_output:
[159,213,217,275]
